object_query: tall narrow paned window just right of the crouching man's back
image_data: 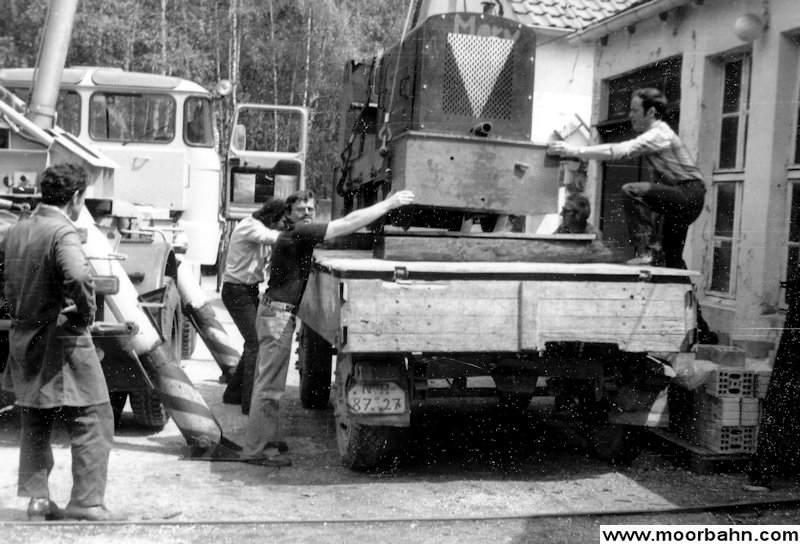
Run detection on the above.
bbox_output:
[708,53,751,297]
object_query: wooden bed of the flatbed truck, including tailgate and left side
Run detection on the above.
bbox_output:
[299,249,699,353]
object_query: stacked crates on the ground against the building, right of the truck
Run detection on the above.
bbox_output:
[690,346,772,453]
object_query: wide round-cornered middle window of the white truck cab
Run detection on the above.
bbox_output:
[89,92,176,143]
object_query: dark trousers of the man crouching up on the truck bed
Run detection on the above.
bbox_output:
[623,181,706,269]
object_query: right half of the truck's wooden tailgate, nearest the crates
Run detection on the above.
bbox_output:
[520,282,694,351]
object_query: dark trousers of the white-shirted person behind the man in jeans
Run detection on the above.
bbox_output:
[221,282,258,414]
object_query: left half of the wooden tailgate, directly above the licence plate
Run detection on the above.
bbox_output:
[341,279,519,352]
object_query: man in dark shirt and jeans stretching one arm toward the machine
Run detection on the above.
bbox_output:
[242,190,414,467]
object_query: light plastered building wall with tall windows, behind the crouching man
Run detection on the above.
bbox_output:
[580,0,800,338]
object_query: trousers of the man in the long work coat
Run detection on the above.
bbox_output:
[17,403,114,507]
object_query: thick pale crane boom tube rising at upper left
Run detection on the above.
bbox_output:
[26,0,78,129]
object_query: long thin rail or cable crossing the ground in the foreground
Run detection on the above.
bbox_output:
[0,499,800,527]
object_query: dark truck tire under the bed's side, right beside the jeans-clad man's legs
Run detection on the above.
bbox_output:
[297,323,333,410]
